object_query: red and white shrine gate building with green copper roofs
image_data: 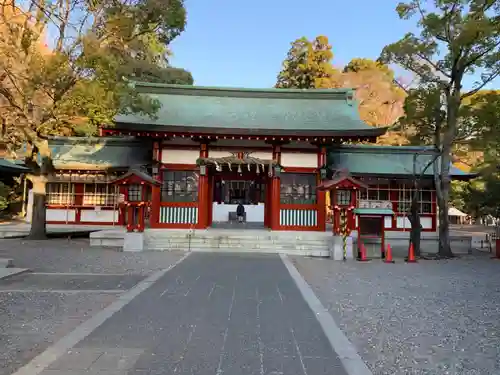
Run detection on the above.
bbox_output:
[32,83,470,239]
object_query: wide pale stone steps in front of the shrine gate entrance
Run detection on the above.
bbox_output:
[91,228,332,257]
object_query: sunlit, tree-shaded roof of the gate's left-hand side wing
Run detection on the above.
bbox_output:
[49,137,152,170]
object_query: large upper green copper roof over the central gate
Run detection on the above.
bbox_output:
[115,83,385,137]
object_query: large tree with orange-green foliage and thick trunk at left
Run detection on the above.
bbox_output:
[0,0,186,238]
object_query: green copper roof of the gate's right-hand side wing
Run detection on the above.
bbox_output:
[328,145,475,178]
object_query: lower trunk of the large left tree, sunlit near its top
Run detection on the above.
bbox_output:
[28,176,47,240]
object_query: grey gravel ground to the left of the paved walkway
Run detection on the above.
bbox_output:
[0,239,184,375]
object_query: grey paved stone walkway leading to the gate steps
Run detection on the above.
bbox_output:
[42,253,346,375]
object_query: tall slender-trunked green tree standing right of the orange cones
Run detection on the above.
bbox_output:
[381,0,500,257]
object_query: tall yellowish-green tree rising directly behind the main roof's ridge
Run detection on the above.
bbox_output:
[275,36,339,89]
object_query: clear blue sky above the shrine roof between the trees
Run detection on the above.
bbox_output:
[170,0,498,88]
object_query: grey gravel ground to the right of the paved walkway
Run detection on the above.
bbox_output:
[293,256,500,375]
